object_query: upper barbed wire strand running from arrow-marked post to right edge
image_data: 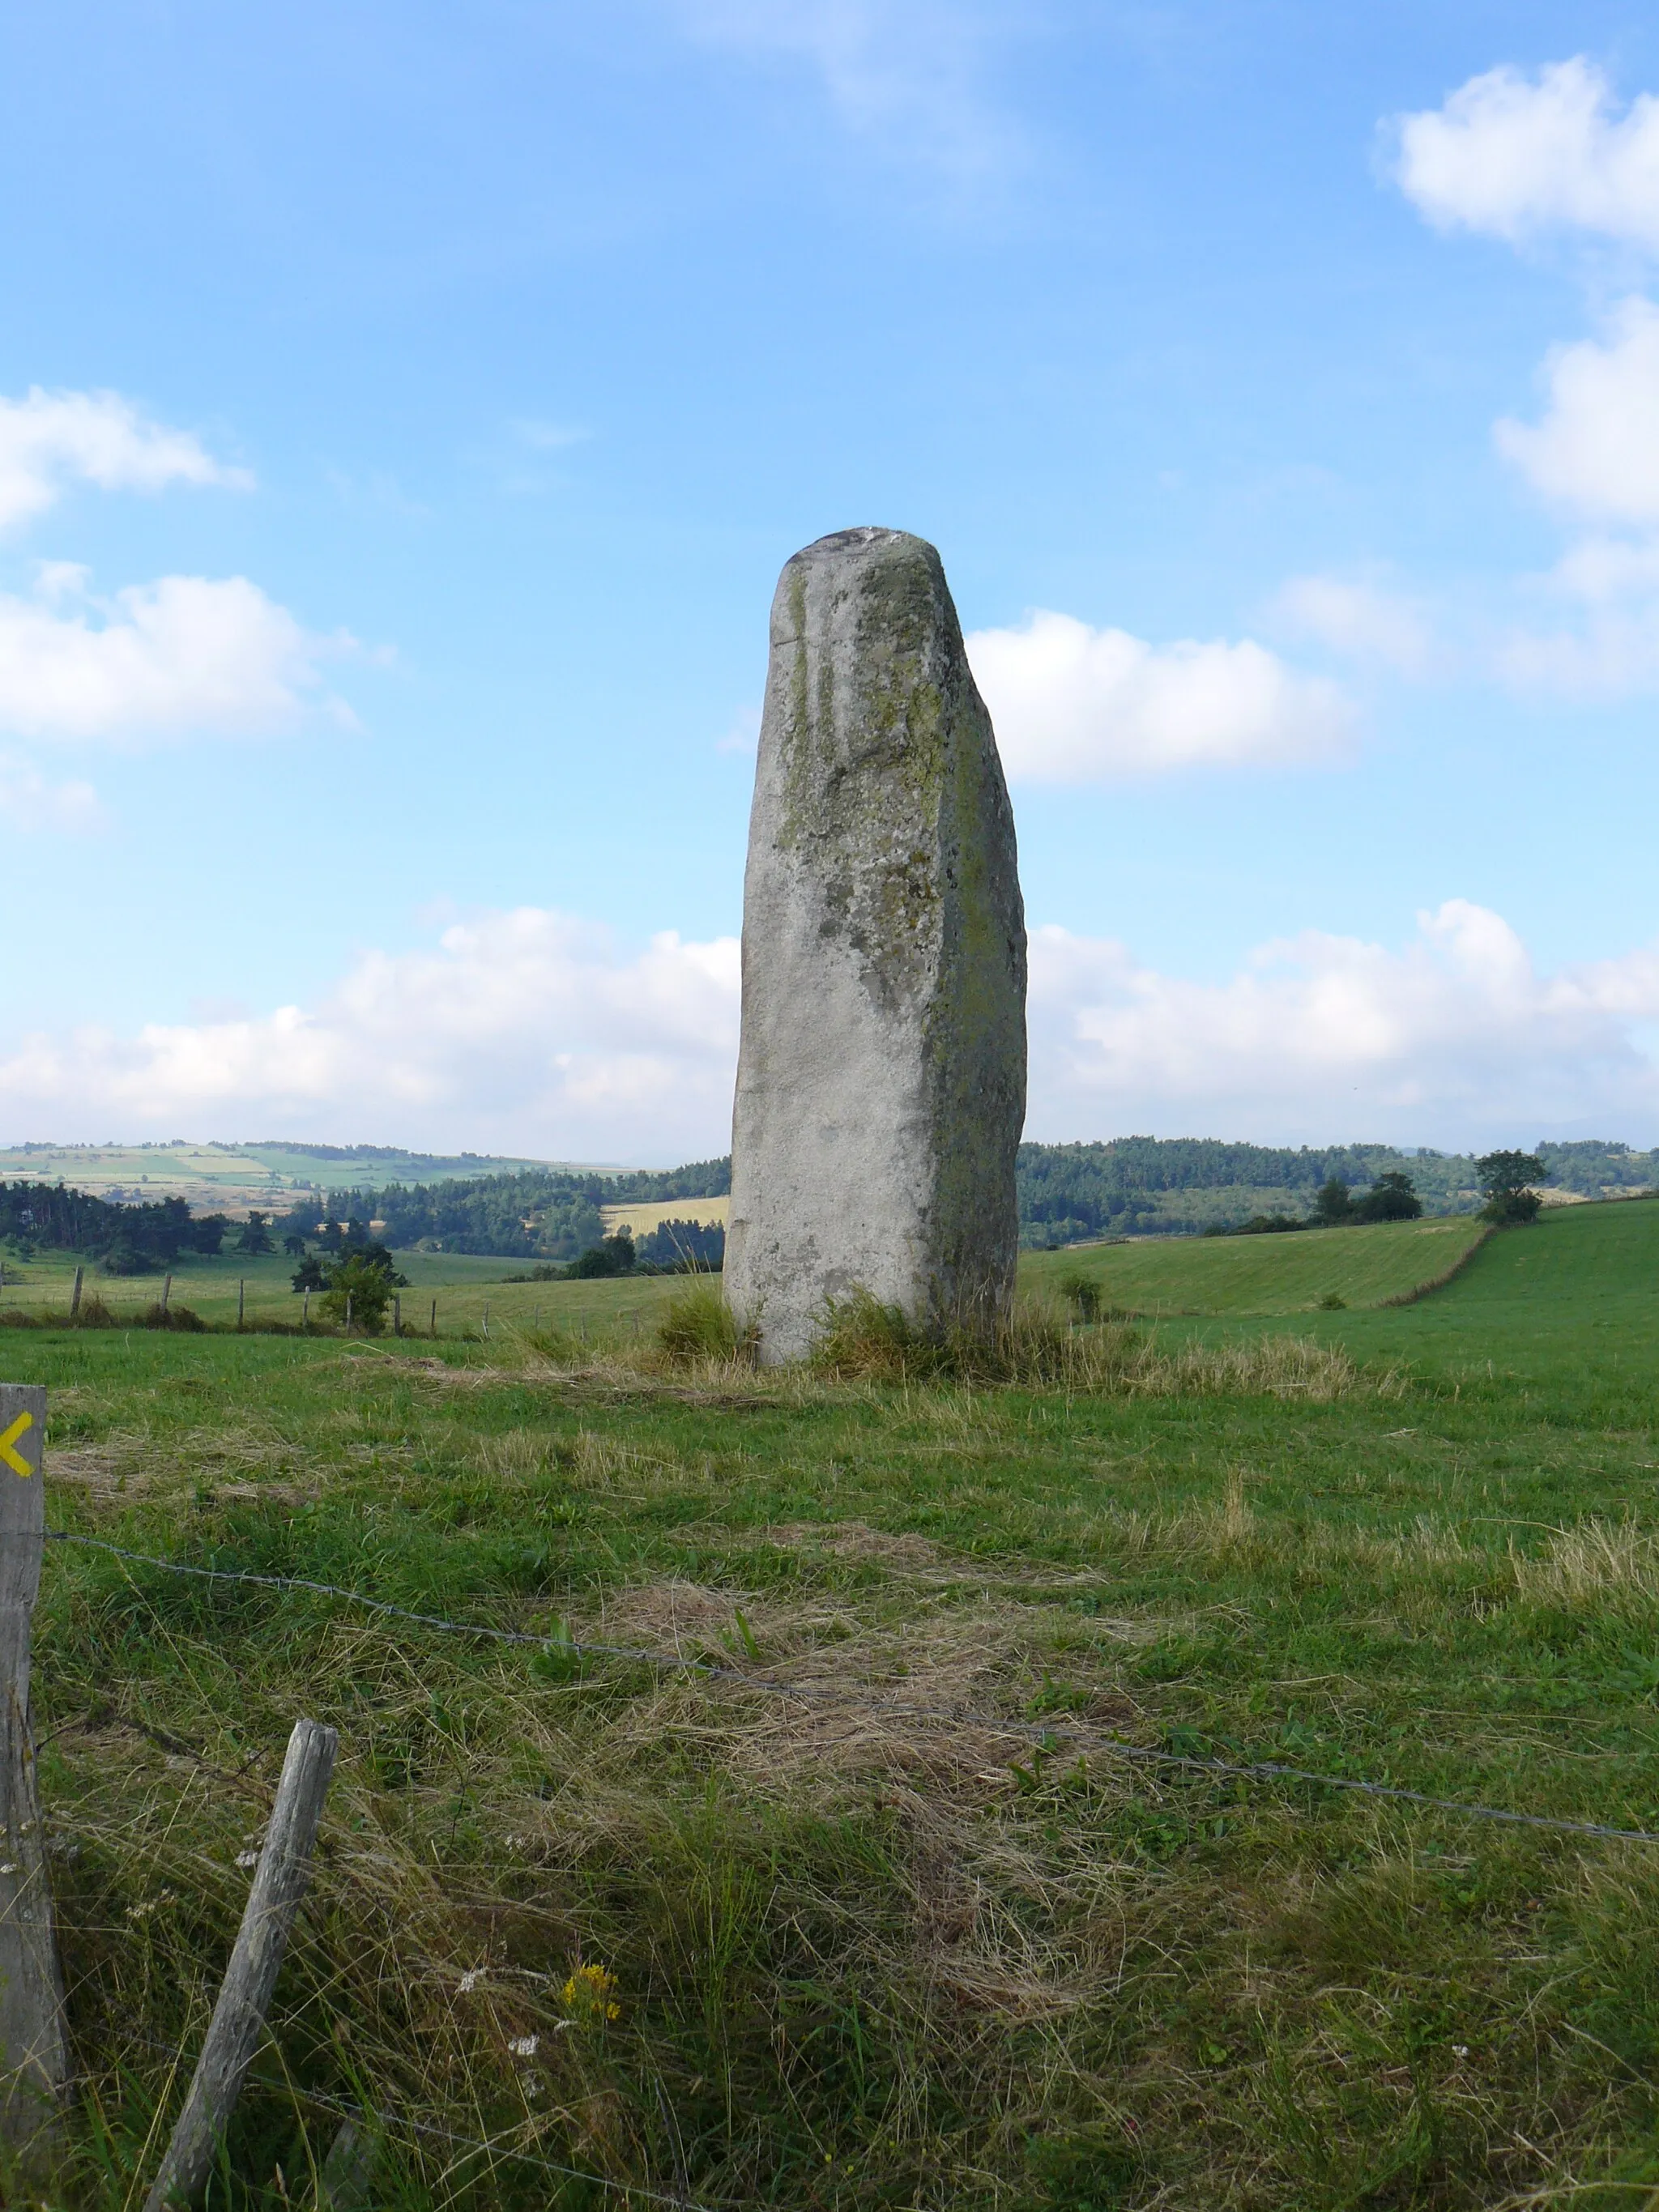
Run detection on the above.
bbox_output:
[46,1528,1659,1843]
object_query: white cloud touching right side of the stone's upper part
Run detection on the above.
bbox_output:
[966,611,1354,783]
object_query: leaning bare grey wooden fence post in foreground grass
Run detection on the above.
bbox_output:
[143,1721,341,2212]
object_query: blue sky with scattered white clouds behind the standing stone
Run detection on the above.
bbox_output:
[0,0,1659,1159]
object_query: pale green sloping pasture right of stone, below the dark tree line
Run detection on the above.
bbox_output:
[1020,1214,1484,1314]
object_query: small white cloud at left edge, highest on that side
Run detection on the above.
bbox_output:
[0,385,252,529]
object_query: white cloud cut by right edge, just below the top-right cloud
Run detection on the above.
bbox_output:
[1495,299,1659,524]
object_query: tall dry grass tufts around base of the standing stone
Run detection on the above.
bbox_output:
[648,1285,1402,1398]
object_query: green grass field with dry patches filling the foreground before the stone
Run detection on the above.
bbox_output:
[0,1204,1659,2212]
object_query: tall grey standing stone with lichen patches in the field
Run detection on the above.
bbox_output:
[726,529,1026,1365]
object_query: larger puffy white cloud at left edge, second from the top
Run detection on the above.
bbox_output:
[0,562,345,739]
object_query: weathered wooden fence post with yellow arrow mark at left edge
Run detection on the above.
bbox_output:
[0,1383,69,2146]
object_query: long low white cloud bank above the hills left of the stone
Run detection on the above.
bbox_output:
[0,907,739,1159]
